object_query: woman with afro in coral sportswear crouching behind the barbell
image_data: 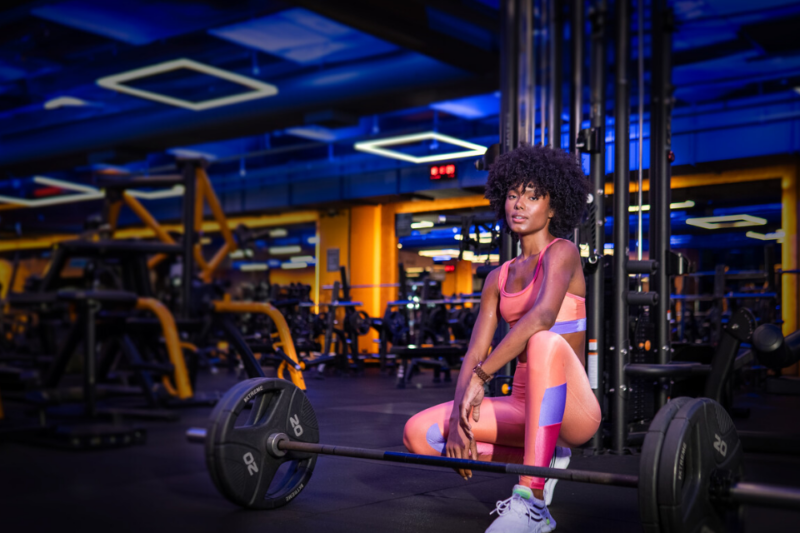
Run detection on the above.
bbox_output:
[403,146,600,533]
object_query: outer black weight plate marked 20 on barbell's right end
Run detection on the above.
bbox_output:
[657,398,742,533]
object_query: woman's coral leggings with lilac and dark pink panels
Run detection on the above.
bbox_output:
[403,331,600,489]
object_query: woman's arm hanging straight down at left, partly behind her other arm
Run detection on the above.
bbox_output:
[450,268,500,424]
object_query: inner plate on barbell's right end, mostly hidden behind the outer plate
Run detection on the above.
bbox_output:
[639,396,692,533]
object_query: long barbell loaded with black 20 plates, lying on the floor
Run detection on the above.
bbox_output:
[187,378,800,533]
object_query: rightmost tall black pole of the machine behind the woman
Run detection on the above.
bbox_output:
[650,0,672,409]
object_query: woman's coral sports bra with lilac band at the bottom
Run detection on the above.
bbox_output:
[498,239,586,335]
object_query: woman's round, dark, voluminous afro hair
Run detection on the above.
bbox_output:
[486,144,591,238]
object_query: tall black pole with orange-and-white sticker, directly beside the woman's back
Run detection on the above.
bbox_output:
[579,0,606,450]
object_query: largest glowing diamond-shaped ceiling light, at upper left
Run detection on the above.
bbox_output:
[97,58,278,111]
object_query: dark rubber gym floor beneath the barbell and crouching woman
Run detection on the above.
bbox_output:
[0,370,800,533]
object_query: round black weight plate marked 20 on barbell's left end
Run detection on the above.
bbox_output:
[206,378,319,509]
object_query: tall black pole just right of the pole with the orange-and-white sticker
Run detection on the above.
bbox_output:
[610,0,630,454]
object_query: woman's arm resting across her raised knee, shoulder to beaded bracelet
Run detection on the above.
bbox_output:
[476,241,580,374]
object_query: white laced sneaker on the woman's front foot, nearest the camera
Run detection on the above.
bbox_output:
[486,485,556,533]
